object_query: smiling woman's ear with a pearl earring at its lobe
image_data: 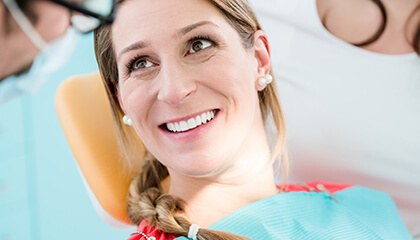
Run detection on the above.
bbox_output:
[254,30,271,91]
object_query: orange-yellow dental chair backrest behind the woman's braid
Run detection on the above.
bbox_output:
[55,73,131,224]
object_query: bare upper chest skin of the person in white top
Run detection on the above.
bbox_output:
[317,0,420,54]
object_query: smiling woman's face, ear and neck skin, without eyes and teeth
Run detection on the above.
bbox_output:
[112,0,277,226]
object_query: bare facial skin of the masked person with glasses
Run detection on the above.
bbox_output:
[0,1,70,81]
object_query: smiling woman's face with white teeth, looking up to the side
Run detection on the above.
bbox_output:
[112,0,268,176]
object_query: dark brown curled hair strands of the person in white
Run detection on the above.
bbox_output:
[324,0,420,55]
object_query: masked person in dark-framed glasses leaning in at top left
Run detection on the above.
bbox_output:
[0,0,115,104]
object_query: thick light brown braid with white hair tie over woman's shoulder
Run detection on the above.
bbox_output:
[127,154,248,240]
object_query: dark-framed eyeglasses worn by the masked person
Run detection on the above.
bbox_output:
[49,0,117,33]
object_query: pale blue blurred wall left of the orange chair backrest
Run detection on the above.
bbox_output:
[0,34,132,240]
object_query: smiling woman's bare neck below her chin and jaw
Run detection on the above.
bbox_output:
[168,109,278,227]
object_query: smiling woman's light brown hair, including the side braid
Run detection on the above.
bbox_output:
[94,0,288,240]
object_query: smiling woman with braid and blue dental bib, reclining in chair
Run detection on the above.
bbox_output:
[95,0,409,239]
